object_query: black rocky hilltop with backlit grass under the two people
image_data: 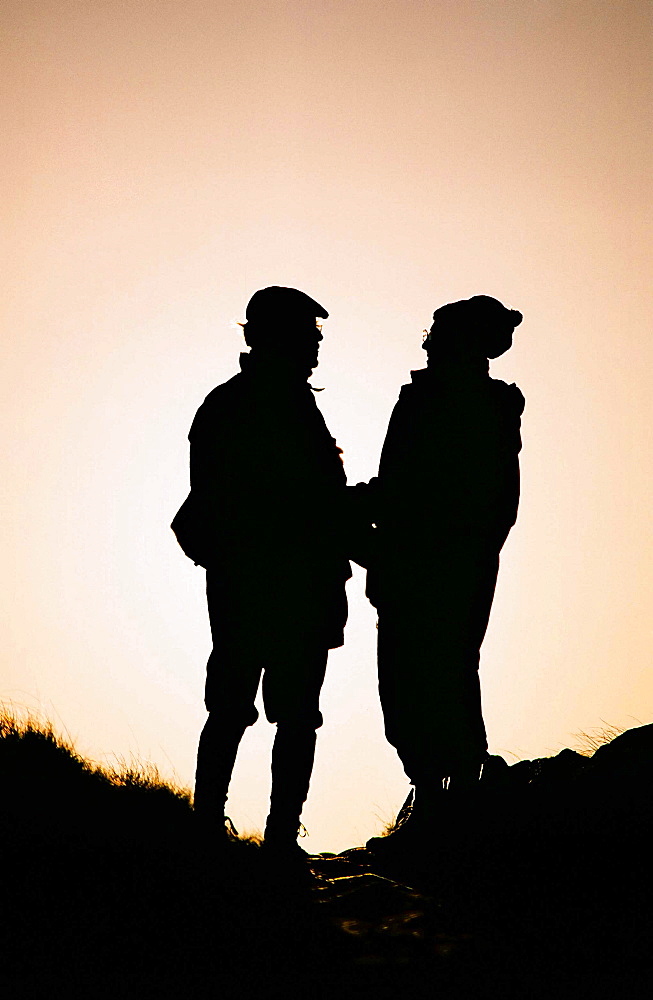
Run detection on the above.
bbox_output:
[0,716,653,998]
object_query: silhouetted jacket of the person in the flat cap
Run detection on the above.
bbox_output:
[173,354,351,644]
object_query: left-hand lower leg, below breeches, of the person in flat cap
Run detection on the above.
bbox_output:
[194,712,247,824]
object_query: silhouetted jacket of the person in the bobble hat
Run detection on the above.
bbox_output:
[368,368,524,602]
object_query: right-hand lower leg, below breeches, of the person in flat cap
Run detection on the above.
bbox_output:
[265,722,316,843]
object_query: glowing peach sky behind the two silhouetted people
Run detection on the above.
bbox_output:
[0,0,653,850]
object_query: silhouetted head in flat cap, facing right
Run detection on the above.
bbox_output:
[243,285,329,376]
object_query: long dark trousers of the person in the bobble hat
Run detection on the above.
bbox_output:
[378,552,498,787]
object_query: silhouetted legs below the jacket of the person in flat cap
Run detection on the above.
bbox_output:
[195,575,328,839]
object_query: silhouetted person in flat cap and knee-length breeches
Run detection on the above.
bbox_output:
[172,286,351,856]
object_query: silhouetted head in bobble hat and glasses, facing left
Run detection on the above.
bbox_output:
[422,295,523,360]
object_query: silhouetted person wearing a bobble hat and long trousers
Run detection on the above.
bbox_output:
[367,295,524,834]
